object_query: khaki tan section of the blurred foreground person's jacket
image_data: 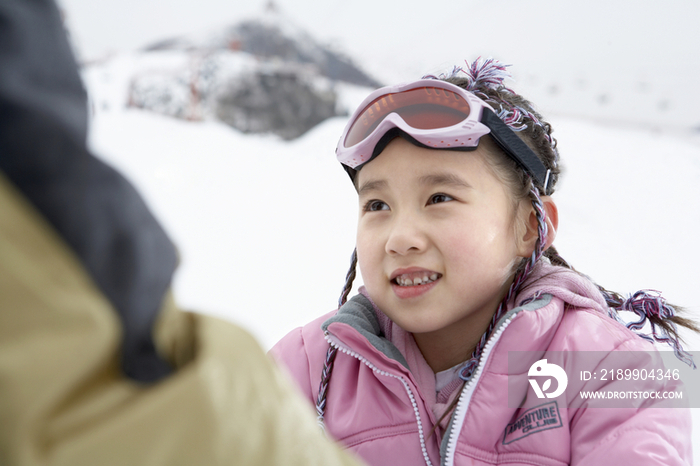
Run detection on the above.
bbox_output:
[0,176,355,466]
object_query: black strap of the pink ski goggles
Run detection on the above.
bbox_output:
[481,108,550,194]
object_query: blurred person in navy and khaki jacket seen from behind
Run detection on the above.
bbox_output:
[0,0,355,466]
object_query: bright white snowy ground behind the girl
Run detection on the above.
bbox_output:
[86,61,700,464]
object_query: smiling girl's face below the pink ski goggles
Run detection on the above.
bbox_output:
[357,138,529,362]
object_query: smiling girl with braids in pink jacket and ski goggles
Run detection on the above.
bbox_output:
[271,60,694,465]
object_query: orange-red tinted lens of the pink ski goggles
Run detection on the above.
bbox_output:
[344,87,470,147]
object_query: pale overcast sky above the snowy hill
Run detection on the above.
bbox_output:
[59,0,700,80]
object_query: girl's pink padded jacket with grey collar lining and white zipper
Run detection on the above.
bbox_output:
[271,263,692,466]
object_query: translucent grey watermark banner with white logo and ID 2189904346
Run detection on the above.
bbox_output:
[508,349,700,408]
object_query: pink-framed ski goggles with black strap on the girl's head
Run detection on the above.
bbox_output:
[335,79,550,194]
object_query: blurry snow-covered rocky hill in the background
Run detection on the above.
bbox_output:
[127,7,380,139]
